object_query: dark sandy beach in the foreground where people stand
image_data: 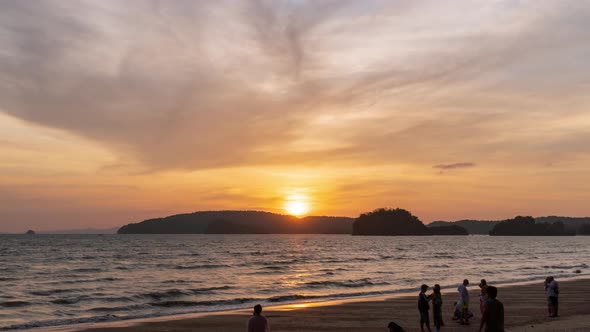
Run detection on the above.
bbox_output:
[77,279,590,332]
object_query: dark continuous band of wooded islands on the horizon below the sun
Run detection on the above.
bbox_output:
[117,208,590,236]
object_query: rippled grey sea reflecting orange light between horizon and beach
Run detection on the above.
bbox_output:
[0,234,590,330]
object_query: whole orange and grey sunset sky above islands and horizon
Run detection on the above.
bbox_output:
[0,0,590,232]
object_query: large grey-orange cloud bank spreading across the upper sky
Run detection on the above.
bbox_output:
[0,0,590,171]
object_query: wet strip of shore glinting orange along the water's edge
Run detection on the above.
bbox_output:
[40,275,590,332]
